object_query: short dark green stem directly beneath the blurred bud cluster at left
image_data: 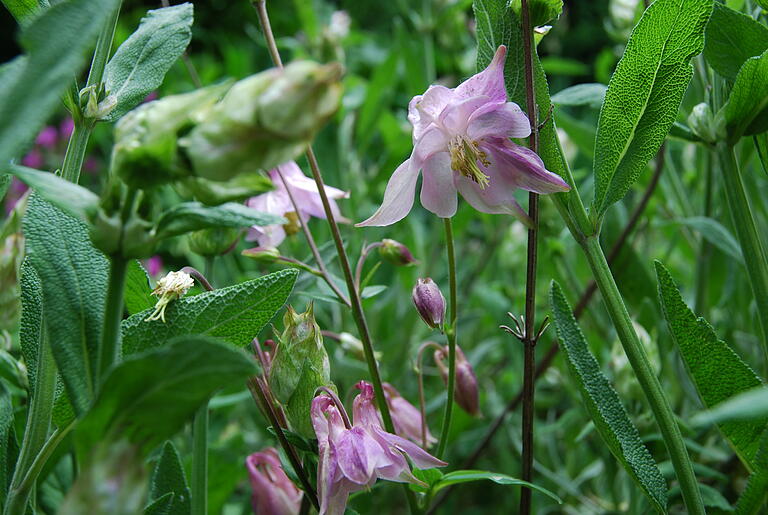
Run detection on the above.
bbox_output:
[96,255,128,383]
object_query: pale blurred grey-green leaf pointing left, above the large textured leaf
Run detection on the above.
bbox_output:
[9,165,99,221]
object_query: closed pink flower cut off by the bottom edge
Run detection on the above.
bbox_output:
[245,447,303,515]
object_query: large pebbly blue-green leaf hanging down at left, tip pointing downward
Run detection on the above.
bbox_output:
[23,195,109,414]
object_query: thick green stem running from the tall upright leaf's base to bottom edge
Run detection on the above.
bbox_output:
[582,236,704,514]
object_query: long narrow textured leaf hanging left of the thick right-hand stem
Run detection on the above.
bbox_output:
[550,281,667,513]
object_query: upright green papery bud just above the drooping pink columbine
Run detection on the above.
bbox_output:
[269,304,335,438]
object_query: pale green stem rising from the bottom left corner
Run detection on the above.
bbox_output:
[3,337,56,515]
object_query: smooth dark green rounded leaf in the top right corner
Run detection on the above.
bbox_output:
[704,2,768,80]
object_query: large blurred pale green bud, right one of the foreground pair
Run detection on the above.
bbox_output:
[180,61,341,181]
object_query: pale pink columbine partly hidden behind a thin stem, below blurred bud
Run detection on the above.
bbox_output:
[246,161,349,248]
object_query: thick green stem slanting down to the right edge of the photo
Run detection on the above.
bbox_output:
[716,142,768,357]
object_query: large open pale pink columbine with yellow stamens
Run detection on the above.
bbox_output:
[357,45,570,227]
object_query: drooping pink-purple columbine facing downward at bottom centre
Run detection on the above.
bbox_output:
[311,381,447,515]
